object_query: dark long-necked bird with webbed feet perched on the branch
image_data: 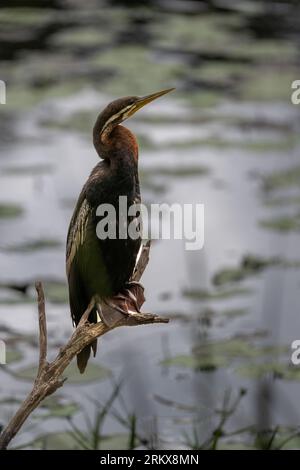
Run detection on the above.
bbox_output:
[66,88,174,373]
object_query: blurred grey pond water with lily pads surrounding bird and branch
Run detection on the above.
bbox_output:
[0,0,300,449]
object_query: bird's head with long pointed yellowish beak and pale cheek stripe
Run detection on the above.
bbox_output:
[93,88,174,155]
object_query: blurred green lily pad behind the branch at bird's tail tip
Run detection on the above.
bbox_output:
[16,361,111,384]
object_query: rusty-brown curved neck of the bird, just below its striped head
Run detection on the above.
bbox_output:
[94,125,138,166]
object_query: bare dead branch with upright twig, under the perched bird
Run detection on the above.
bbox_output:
[0,243,169,450]
